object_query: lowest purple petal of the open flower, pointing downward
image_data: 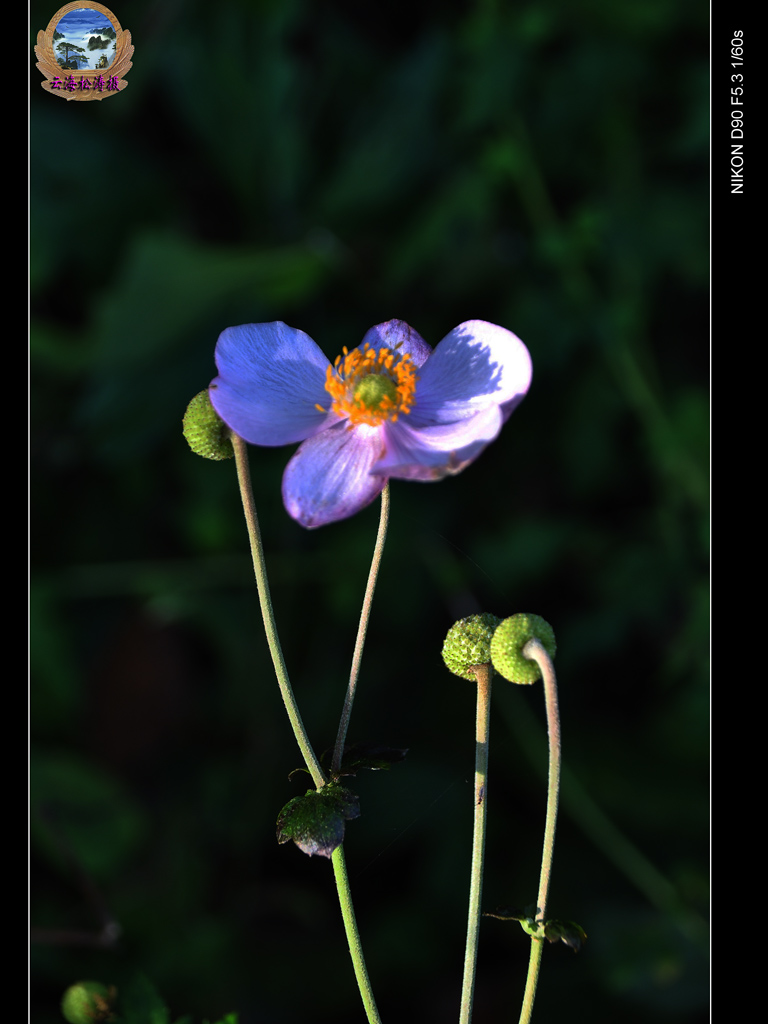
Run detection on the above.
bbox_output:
[283,421,386,529]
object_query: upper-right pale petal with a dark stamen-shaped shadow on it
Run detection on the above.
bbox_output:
[409,321,531,427]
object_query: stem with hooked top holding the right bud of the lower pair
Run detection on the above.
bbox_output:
[520,637,561,1024]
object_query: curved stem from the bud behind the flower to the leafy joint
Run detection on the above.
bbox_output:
[230,432,326,790]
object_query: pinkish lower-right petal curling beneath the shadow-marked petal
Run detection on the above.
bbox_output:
[371,406,504,480]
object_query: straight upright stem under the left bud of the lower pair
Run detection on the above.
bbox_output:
[459,664,494,1024]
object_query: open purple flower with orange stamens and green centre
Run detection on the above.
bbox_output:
[210,319,531,528]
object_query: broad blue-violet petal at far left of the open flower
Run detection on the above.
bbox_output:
[210,321,339,445]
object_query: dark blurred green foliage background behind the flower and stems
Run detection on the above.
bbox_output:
[31,0,709,1024]
